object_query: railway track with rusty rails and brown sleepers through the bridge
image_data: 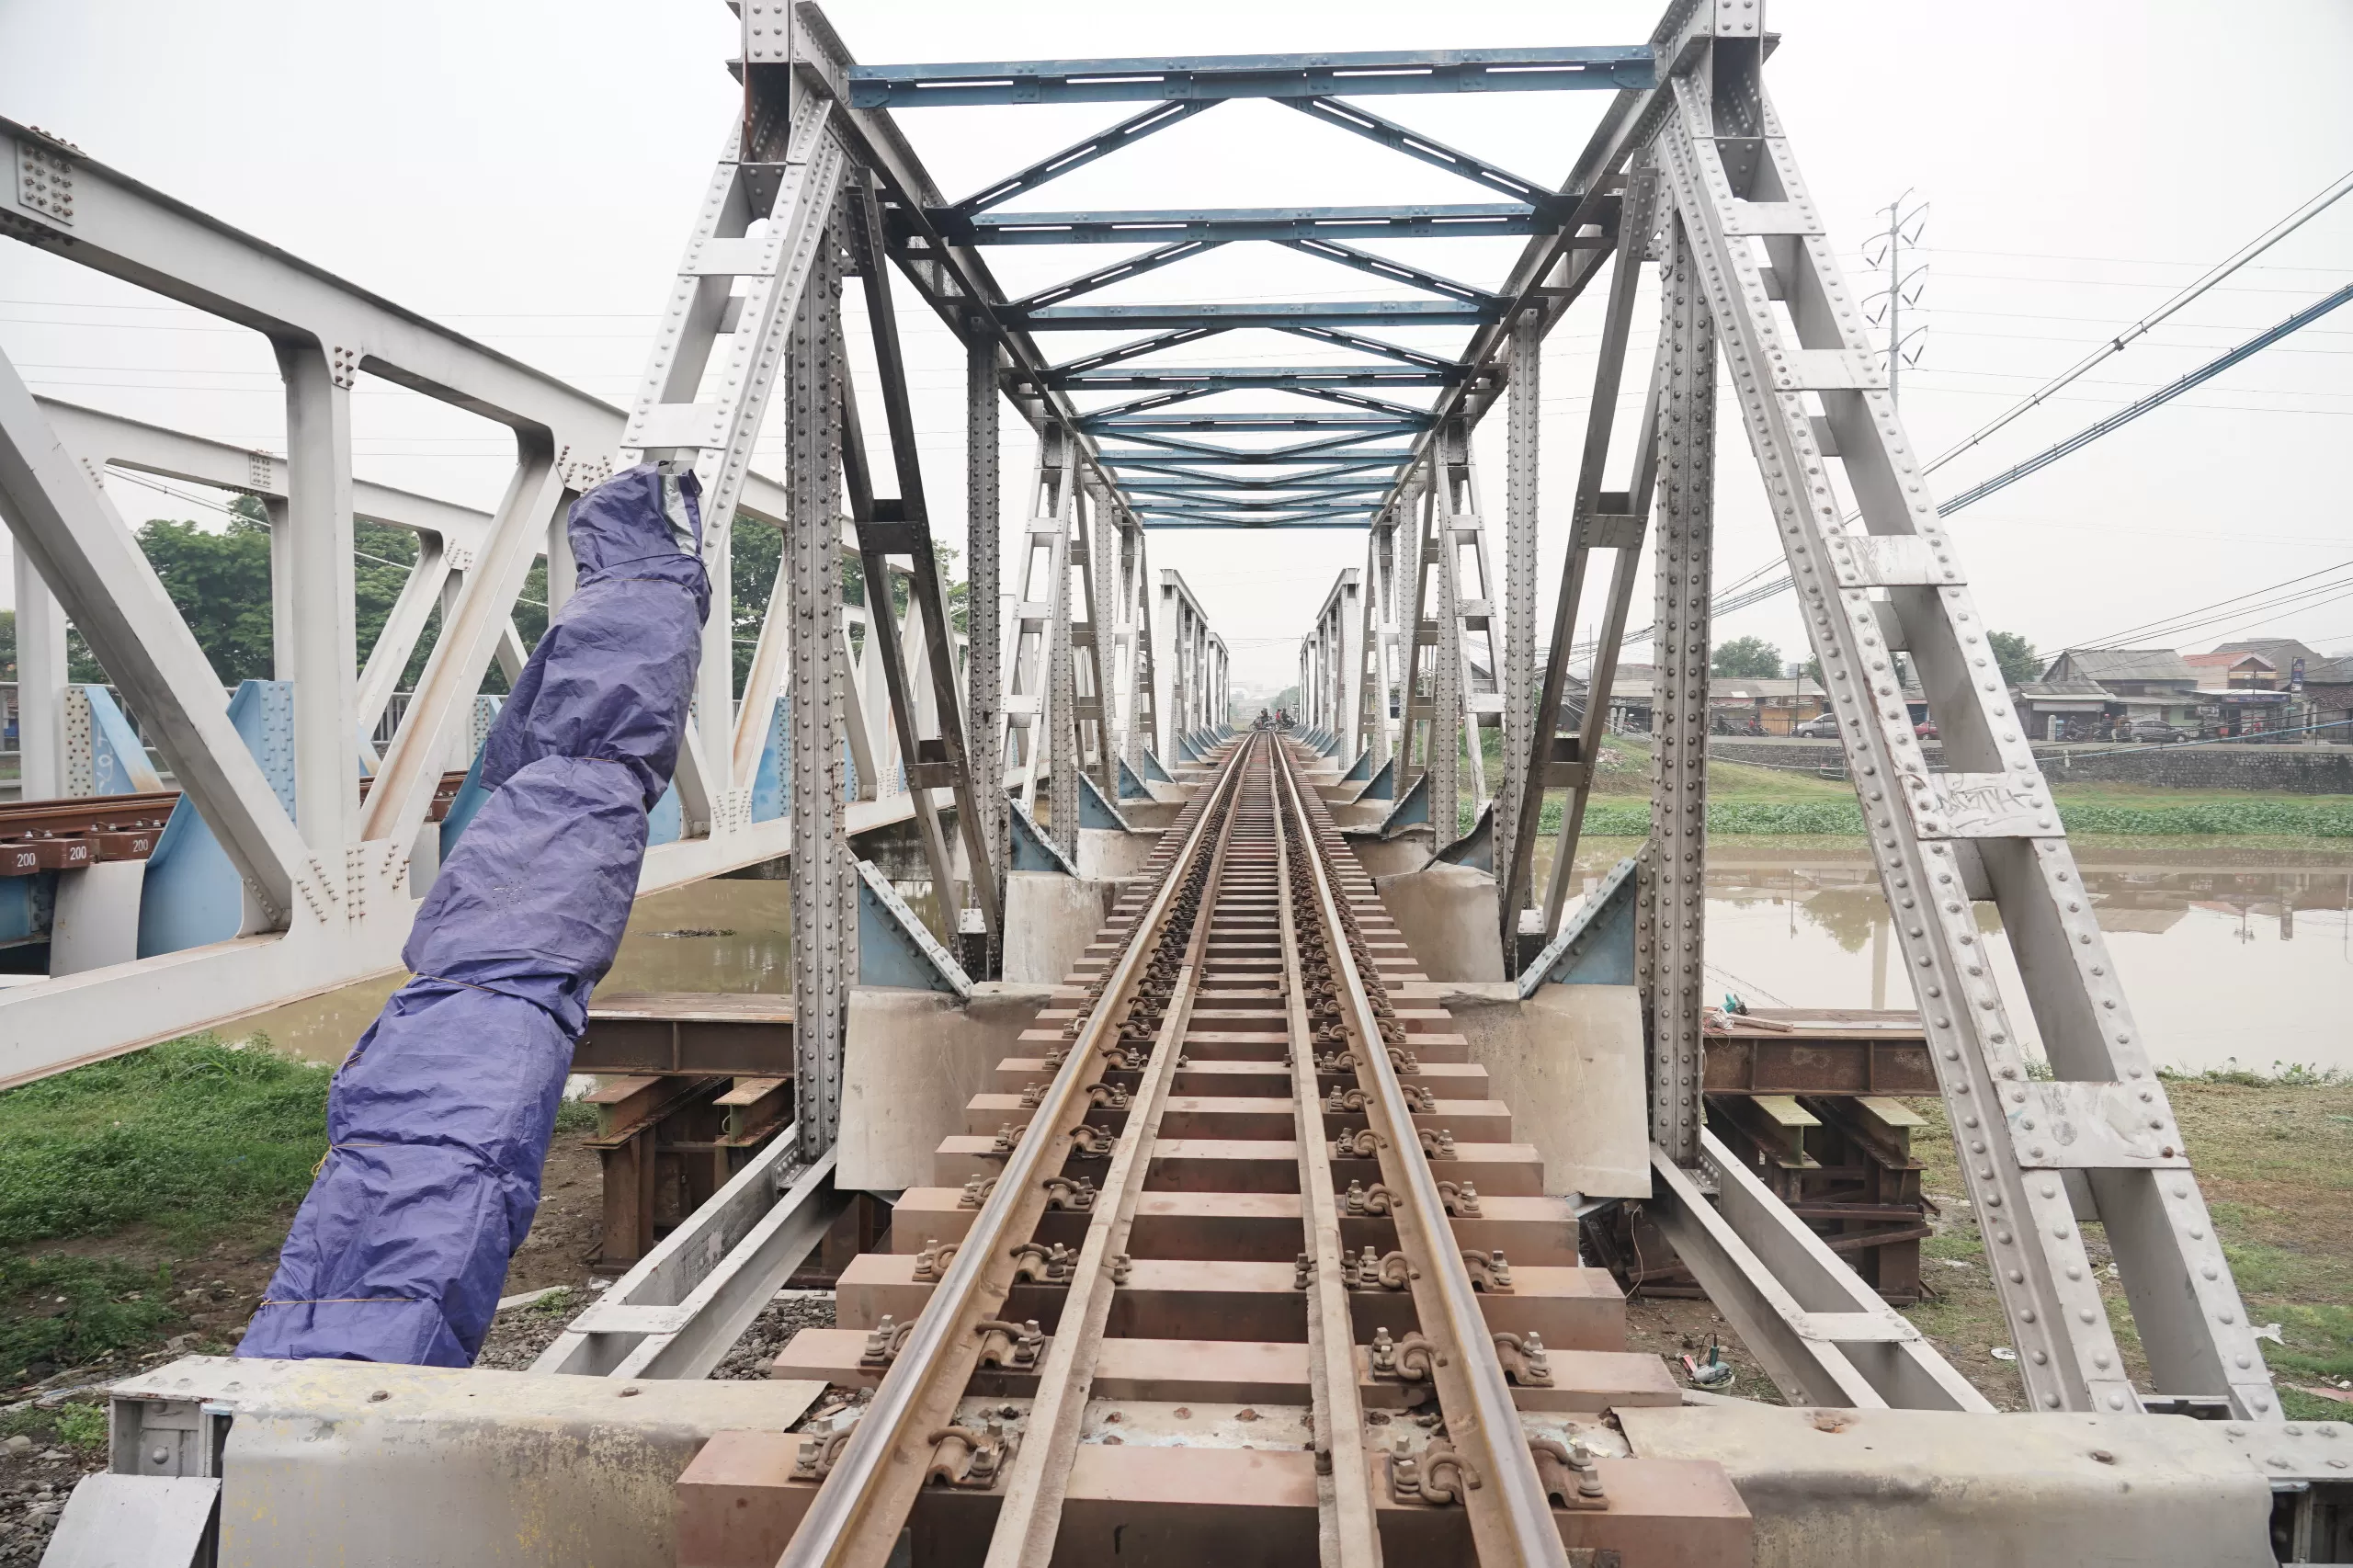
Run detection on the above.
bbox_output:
[774,733,1748,1568]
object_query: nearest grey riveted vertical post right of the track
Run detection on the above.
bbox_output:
[1635,207,1715,1168]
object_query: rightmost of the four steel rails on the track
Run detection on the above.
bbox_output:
[1276,746,1570,1568]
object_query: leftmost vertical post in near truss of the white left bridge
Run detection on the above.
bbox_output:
[278,344,360,861]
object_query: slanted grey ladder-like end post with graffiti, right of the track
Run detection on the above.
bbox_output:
[1659,38,2280,1420]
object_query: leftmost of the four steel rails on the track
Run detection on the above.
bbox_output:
[777,746,1245,1568]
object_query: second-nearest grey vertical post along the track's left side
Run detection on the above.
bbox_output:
[965,332,1012,918]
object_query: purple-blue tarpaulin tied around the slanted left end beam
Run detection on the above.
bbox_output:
[238,464,710,1366]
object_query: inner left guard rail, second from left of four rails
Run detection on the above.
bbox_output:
[986,737,1261,1568]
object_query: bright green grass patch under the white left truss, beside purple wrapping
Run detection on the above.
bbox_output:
[0,1034,332,1245]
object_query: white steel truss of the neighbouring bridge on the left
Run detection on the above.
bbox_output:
[0,112,964,1081]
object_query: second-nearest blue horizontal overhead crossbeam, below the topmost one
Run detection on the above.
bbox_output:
[932,202,1551,244]
